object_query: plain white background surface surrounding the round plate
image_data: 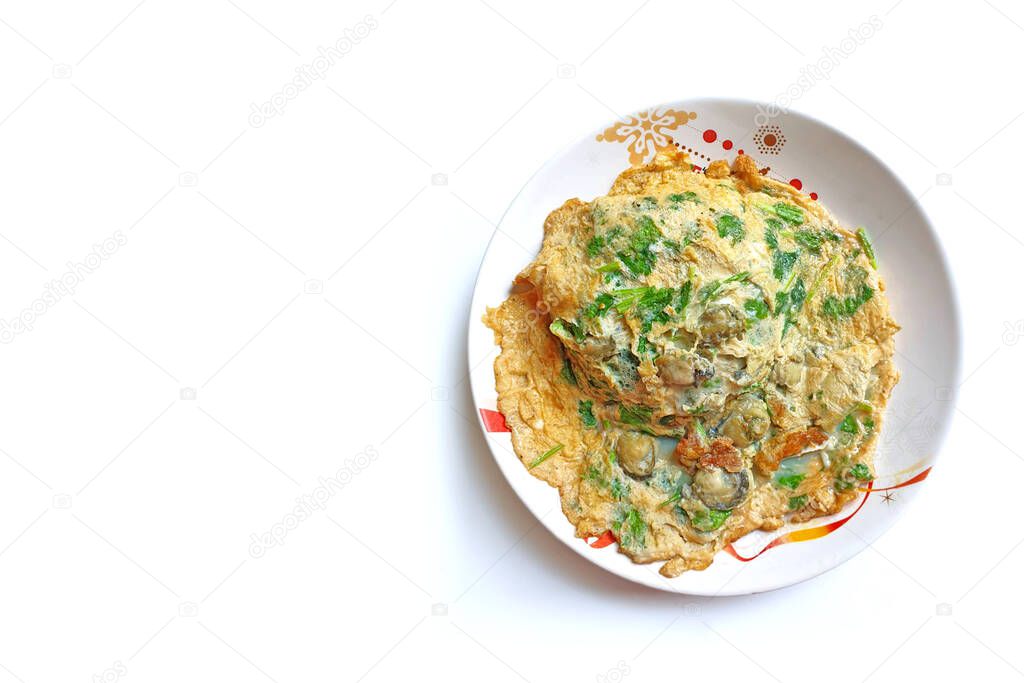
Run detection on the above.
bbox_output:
[0,0,1024,683]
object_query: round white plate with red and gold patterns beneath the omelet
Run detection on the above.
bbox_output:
[468,99,961,595]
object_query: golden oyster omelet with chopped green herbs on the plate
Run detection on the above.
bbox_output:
[484,152,899,578]
